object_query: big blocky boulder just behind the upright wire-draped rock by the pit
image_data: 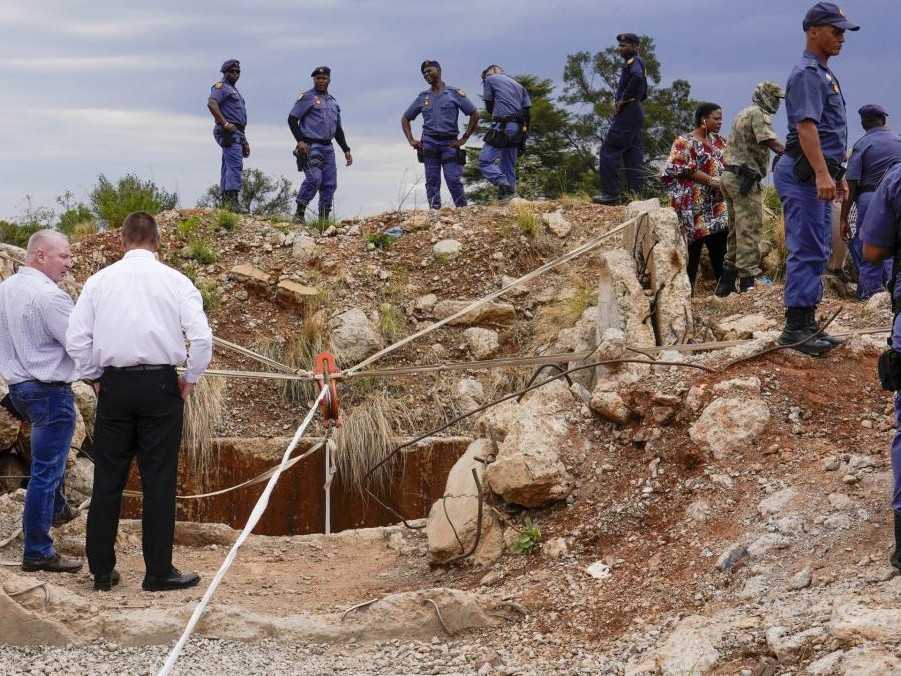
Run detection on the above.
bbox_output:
[479,380,576,507]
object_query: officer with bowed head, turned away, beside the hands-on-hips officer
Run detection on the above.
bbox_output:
[479,65,532,201]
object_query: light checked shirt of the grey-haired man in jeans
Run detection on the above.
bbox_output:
[0,265,76,385]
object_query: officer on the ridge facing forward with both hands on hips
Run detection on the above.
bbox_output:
[400,60,479,209]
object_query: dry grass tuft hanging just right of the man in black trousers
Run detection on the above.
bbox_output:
[181,376,225,490]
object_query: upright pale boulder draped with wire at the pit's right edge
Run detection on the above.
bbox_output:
[426,439,504,565]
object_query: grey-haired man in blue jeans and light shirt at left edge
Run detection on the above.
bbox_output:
[0,230,82,573]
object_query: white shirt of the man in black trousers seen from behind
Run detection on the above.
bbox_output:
[66,249,213,383]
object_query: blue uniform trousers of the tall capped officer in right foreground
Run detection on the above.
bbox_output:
[773,155,832,308]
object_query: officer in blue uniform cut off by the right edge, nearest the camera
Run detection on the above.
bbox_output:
[858,164,901,571]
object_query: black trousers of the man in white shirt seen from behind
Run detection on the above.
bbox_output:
[86,368,184,577]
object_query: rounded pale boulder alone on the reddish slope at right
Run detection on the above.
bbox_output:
[688,397,770,459]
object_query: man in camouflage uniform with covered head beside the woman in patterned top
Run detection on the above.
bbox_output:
[715,82,785,297]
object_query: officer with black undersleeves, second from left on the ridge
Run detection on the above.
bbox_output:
[288,66,353,223]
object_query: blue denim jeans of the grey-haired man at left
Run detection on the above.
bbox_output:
[9,380,75,559]
